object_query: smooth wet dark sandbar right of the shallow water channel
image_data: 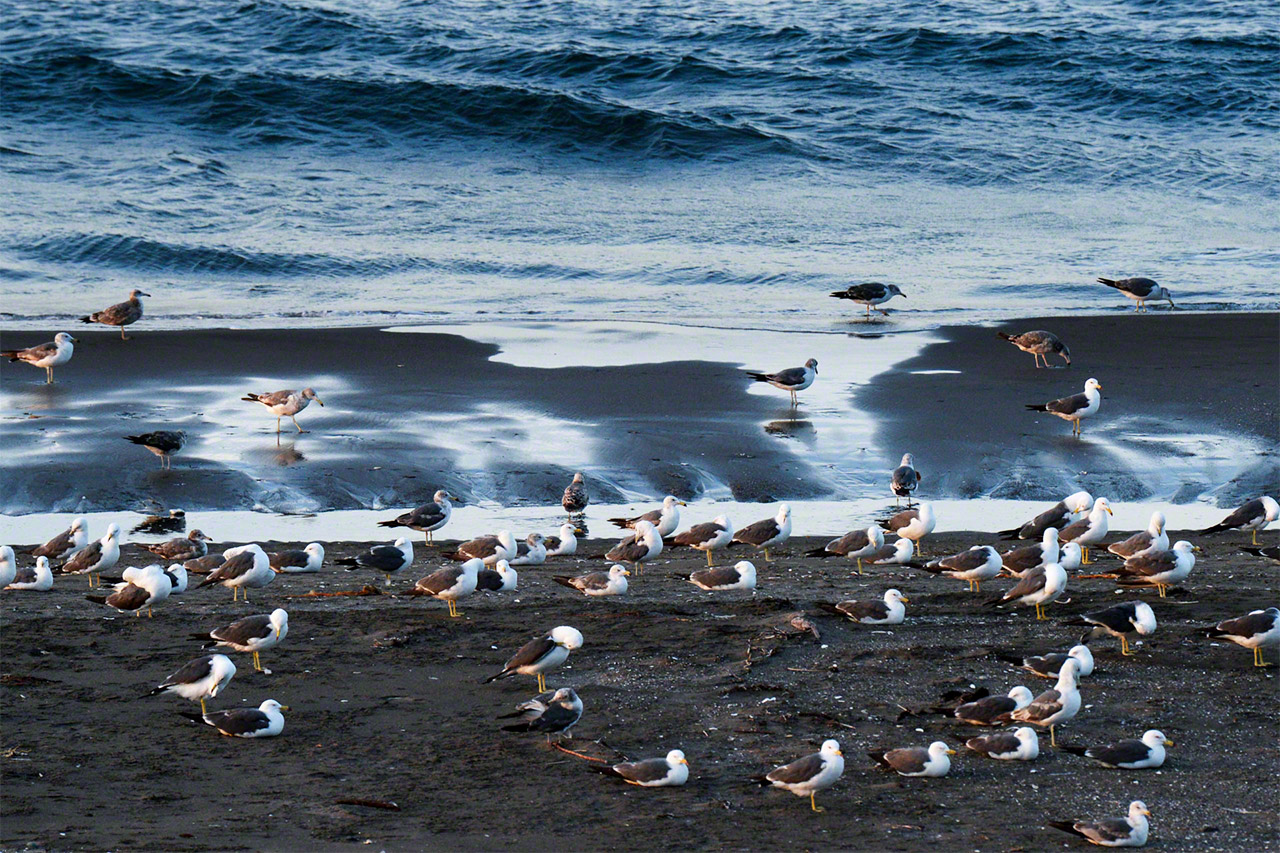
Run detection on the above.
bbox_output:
[854,313,1280,506]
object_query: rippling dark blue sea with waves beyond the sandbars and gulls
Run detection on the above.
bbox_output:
[0,0,1280,329]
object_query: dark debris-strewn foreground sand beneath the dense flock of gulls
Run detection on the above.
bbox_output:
[0,527,1280,852]
